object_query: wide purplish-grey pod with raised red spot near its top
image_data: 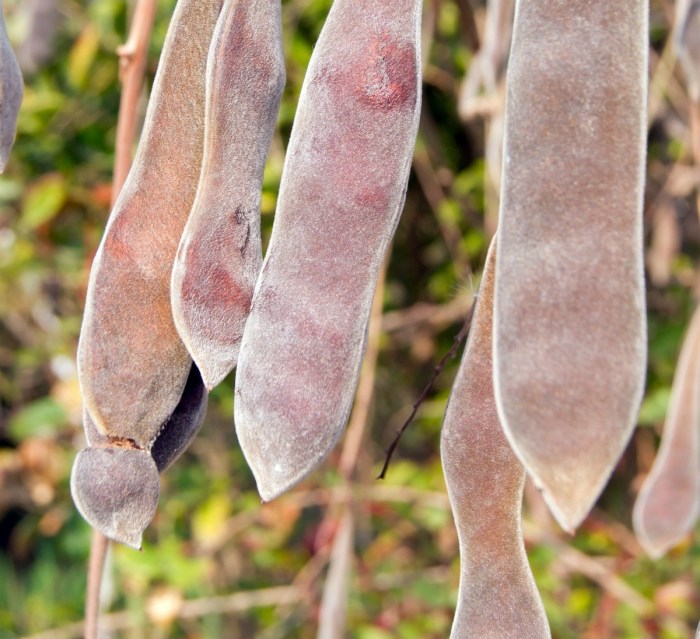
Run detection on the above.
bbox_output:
[235,0,421,500]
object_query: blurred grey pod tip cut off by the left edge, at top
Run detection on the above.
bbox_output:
[0,4,24,173]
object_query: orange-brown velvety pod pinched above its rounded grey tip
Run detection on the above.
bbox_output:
[71,0,221,546]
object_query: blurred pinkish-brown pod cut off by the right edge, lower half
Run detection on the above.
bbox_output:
[633,308,700,558]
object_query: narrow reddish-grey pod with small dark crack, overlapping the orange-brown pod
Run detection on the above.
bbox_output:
[171,0,285,389]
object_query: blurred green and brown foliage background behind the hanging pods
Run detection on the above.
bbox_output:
[0,0,700,639]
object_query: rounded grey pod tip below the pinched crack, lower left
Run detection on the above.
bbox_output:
[71,447,160,550]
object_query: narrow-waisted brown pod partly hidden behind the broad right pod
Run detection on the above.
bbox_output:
[440,239,551,639]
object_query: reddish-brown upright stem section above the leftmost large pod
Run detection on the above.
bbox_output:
[112,0,157,205]
